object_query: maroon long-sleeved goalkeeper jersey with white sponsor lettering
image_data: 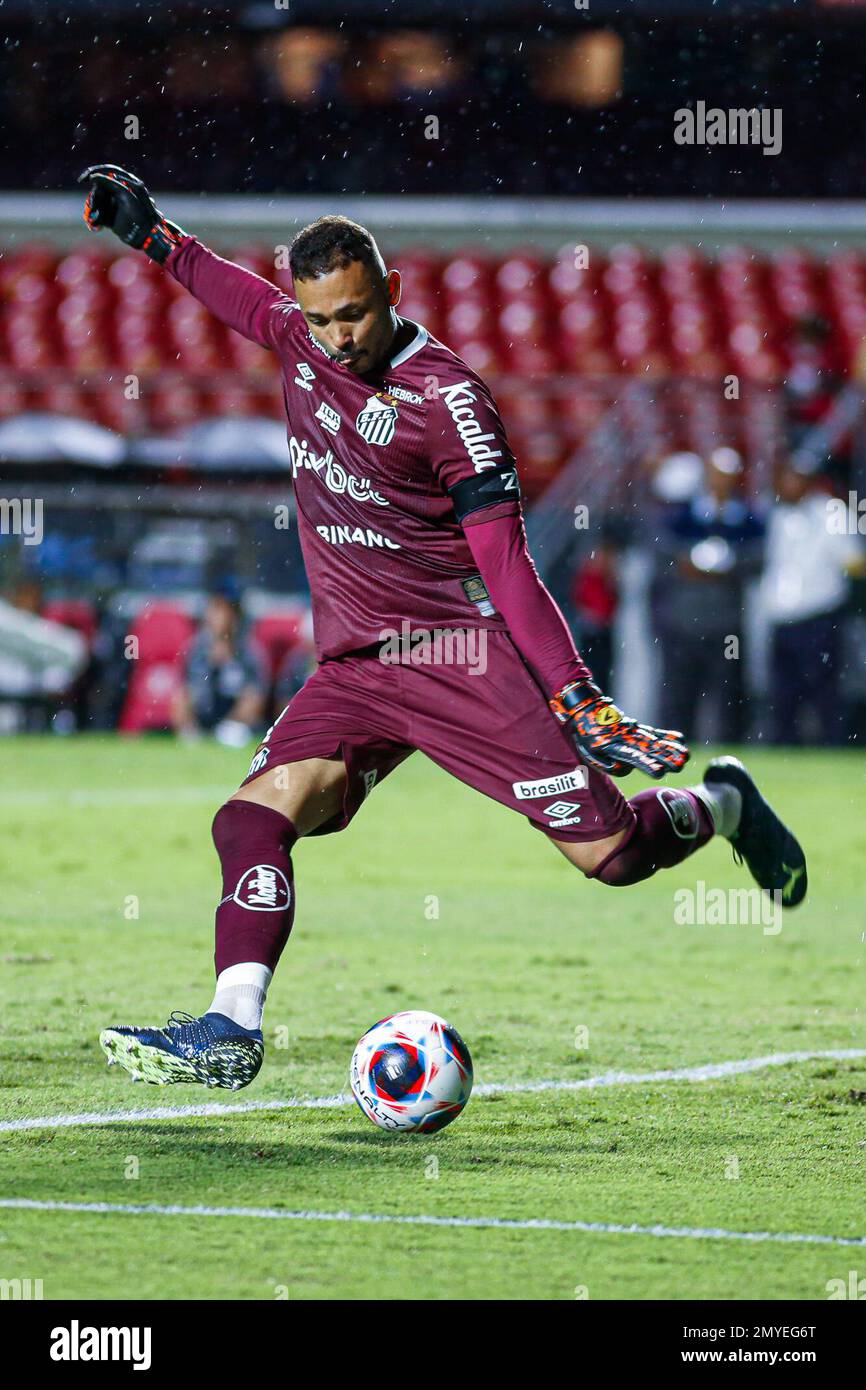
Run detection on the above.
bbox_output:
[165,236,585,691]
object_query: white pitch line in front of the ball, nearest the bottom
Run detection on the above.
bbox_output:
[0,1197,866,1247]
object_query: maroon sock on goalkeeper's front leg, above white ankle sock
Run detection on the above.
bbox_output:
[213,801,297,974]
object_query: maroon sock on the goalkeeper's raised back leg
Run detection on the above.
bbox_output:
[587,787,714,888]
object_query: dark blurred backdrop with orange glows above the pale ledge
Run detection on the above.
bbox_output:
[0,0,866,199]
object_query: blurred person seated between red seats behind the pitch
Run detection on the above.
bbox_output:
[172,591,267,748]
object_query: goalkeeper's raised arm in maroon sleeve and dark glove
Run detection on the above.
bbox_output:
[78,164,292,348]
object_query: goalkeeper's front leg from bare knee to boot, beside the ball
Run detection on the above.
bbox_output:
[99,758,346,1091]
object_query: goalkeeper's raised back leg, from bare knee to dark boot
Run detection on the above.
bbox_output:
[550,758,808,908]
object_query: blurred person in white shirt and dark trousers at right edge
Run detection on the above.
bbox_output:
[763,464,863,744]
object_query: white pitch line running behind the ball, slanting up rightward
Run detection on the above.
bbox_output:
[0,1048,866,1134]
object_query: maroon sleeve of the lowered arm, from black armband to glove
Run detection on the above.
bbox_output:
[464,503,591,695]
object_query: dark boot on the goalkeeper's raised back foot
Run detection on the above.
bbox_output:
[703,758,808,908]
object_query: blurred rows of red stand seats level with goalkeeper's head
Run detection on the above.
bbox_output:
[0,242,866,487]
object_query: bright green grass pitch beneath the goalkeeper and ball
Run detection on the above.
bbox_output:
[0,738,866,1300]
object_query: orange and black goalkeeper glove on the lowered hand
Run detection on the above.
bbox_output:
[550,681,689,778]
